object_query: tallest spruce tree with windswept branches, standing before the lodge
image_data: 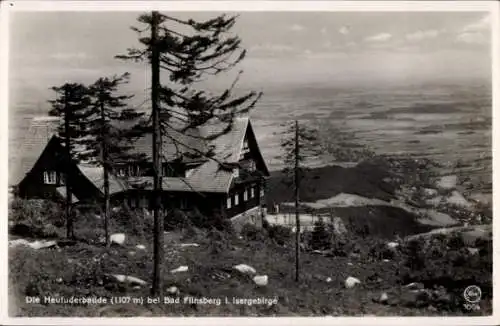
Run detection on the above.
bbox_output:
[117,11,261,295]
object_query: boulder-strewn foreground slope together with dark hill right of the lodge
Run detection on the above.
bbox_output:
[9,157,492,317]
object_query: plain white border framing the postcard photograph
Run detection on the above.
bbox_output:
[0,1,500,326]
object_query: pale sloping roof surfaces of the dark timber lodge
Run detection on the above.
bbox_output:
[13,117,267,194]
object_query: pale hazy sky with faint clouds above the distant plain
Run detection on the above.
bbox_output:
[9,12,491,101]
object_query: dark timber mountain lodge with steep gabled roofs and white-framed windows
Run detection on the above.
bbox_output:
[9,117,269,228]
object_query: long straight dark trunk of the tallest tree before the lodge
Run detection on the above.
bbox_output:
[151,11,164,296]
